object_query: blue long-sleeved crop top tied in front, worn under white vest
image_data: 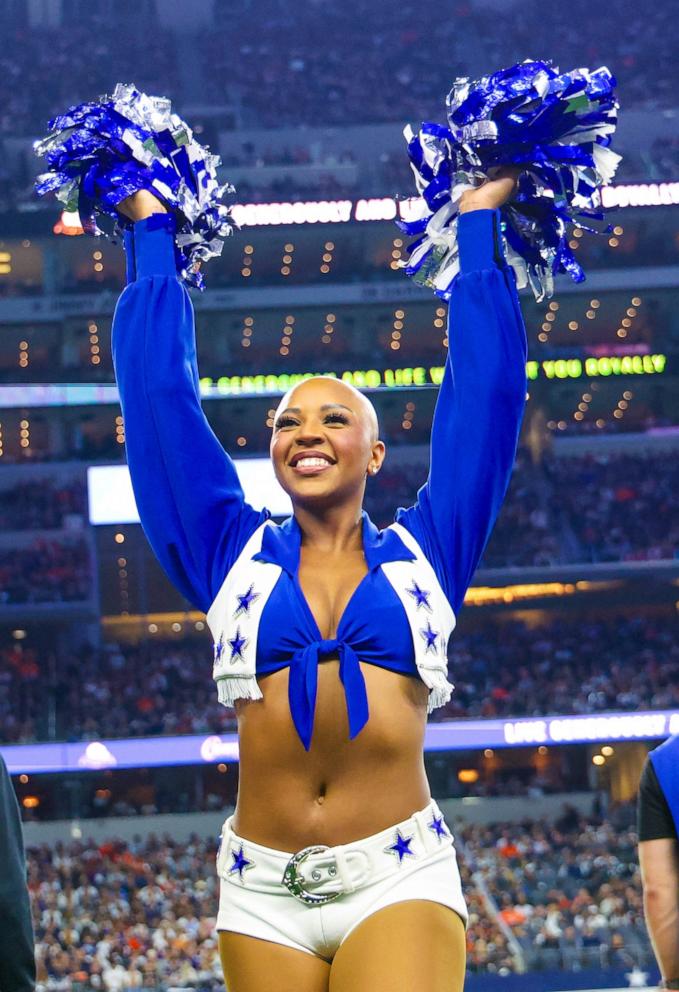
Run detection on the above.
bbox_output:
[112,210,526,749]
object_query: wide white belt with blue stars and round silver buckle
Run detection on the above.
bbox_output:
[217,799,453,906]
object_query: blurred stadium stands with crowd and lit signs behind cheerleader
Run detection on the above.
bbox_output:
[0,0,679,992]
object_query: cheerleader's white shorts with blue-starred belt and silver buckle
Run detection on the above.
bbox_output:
[216,799,468,959]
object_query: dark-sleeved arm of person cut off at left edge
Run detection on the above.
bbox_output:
[0,756,35,992]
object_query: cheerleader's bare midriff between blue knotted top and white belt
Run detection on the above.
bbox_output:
[233,658,431,852]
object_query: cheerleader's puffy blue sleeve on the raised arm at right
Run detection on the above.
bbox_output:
[396,210,527,614]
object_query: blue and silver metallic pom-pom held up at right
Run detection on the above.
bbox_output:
[398,61,621,300]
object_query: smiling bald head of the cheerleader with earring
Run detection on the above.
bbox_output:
[271,376,384,509]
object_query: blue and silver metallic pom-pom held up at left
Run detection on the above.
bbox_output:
[34,83,233,289]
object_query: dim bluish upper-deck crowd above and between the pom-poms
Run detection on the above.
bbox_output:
[0,0,679,207]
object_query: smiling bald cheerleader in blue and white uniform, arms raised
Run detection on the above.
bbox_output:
[113,169,526,992]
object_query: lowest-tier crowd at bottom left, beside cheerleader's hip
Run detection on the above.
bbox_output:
[28,835,223,992]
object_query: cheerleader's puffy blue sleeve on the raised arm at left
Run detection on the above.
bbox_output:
[112,214,269,612]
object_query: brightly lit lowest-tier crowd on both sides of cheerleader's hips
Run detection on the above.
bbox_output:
[28,808,651,992]
